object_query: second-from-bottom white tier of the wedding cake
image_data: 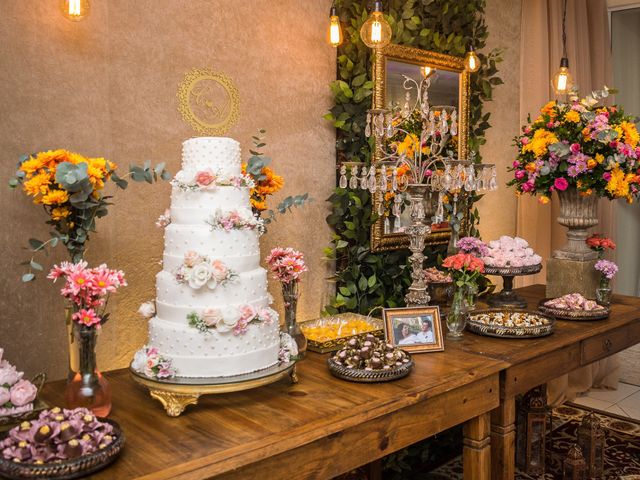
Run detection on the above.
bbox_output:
[156,268,267,307]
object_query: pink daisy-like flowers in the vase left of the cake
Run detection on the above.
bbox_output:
[47,260,127,328]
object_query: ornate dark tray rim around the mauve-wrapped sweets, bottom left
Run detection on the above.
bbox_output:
[0,418,125,480]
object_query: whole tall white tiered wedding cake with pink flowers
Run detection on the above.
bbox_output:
[132,137,280,378]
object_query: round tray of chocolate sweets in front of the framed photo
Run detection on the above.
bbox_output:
[327,334,413,383]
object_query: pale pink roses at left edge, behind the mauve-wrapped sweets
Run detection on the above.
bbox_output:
[0,348,38,417]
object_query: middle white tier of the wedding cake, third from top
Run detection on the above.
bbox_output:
[164,223,260,262]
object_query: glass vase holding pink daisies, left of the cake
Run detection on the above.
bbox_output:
[65,322,111,417]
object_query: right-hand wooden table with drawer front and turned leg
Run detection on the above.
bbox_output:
[445,285,640,480]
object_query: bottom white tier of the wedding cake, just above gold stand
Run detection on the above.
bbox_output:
[149,318,280,377]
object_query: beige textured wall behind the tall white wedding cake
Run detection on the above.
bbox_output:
[0,0,335,378]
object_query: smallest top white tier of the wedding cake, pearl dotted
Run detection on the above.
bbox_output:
[182,137,240,176]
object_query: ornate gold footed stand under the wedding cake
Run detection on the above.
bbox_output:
[129,361,298,417]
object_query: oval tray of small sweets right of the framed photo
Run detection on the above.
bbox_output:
[467,308,555,338]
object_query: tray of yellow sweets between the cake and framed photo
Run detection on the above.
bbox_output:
[300,313,384,353]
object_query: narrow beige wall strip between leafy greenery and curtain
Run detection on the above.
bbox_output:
[478,0,521,253]
